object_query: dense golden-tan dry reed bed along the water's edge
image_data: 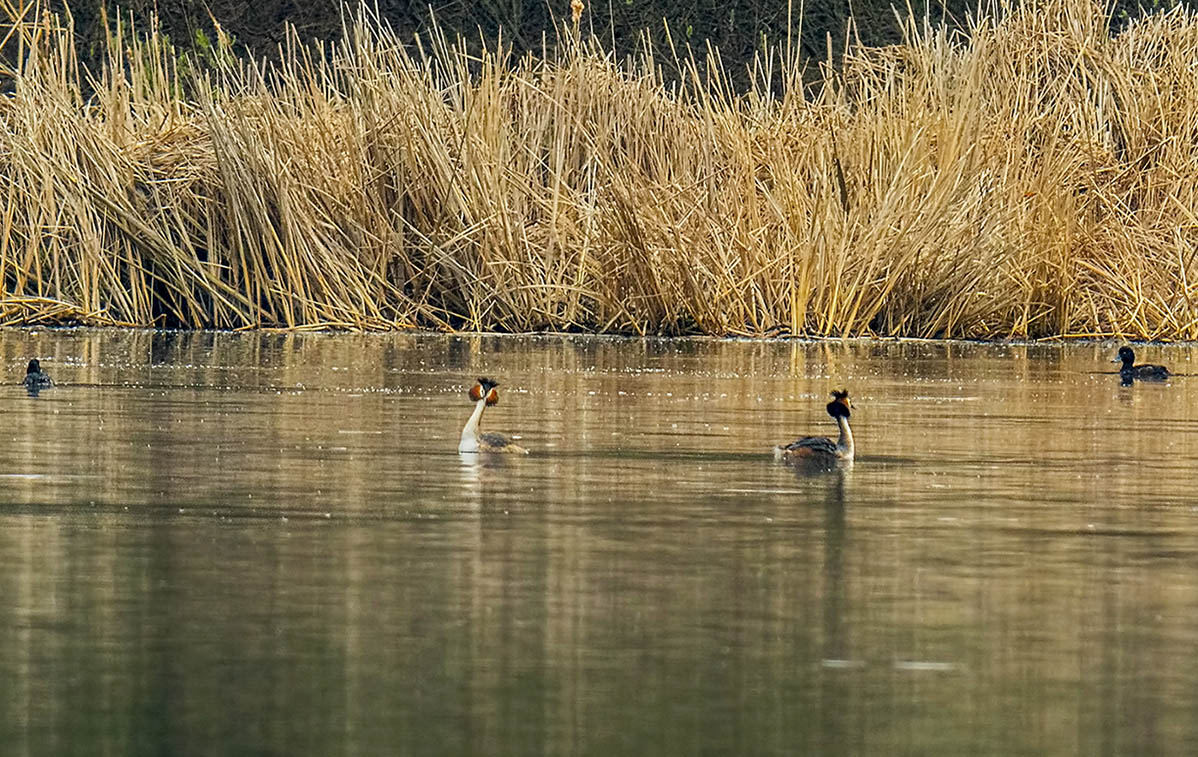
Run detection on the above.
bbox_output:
[0,0,1198,339]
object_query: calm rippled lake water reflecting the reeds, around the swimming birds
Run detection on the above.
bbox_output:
[0,329,1198,756]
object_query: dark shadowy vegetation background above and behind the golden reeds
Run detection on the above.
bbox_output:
[44,0,1178,83]
